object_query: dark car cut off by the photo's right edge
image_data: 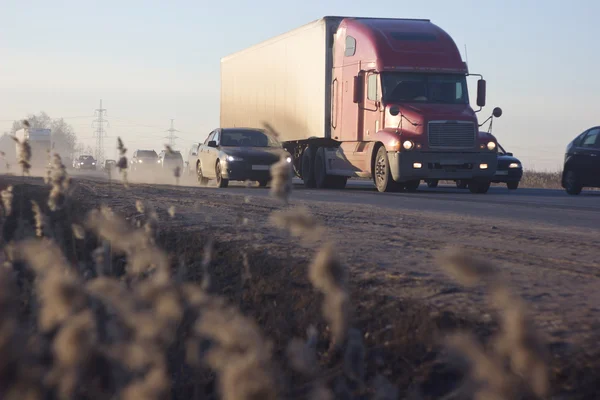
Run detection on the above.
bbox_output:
[562,126,600,195]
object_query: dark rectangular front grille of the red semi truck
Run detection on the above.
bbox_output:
[428,121,475,149]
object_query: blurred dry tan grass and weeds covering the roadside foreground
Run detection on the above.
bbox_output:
[0,140,596,400]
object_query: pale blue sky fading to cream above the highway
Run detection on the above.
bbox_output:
[0,0,600,170]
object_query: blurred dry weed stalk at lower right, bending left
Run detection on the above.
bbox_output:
[439,250,549,399]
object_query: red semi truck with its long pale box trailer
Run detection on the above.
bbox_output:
[220,17,501,193]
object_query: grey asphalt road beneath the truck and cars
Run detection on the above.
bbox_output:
[71,171,600,230]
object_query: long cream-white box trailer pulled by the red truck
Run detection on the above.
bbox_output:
[220,17,343,141]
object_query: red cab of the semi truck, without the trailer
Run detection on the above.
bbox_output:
[325,18,497,193]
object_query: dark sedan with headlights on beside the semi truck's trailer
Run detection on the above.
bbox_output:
[196,128,292,187]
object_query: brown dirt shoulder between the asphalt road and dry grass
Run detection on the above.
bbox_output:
[0,173,600,399]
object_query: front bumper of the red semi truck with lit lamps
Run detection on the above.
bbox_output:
[388,151,498,182]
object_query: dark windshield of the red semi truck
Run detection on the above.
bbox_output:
[381,72,469,104]
